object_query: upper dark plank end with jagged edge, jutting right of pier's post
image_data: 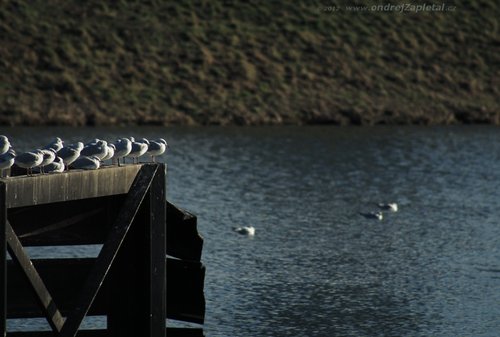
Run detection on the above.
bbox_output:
[167,201,203,261]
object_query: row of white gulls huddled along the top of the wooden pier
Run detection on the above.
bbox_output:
[0,135,168,176]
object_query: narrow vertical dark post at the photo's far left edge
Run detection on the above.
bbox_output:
[0,182,7,337]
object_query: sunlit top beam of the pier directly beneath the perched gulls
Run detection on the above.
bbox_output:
[0,164,141,208]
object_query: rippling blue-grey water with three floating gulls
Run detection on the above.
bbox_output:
[0,126,500,337]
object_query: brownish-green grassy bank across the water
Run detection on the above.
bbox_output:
[0,0,500,125]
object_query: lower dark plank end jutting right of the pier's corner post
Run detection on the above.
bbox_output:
[167,258,205,324]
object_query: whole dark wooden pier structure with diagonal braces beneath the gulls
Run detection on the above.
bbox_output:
[0,164,205,337]
